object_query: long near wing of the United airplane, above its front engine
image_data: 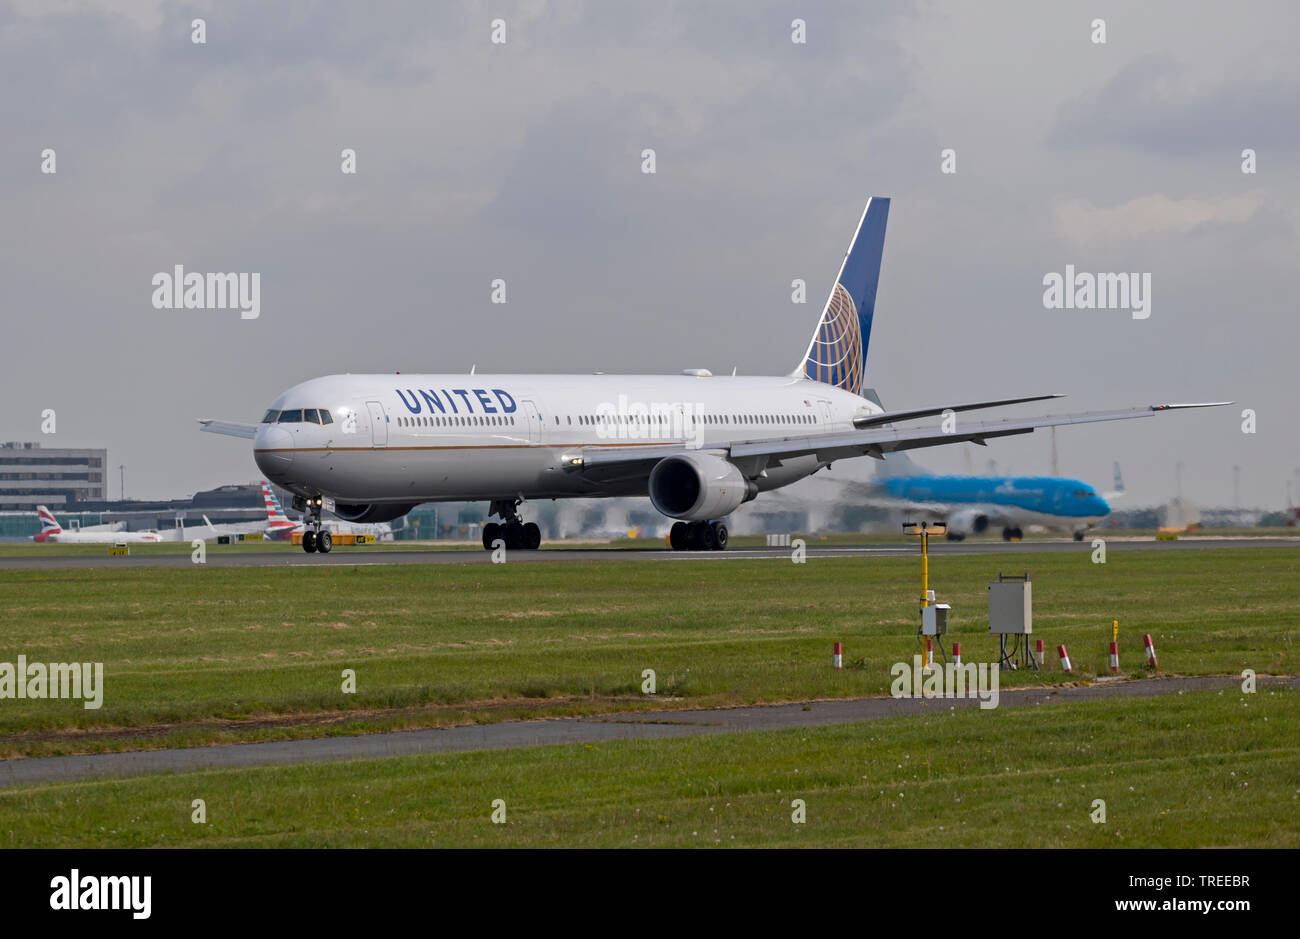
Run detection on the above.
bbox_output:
[567,401,1232,481]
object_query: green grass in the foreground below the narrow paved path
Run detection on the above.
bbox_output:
[0,689,1300,848]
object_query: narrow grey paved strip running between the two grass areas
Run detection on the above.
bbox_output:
[0,676,1300,787]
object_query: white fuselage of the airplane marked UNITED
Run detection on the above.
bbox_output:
[254,375,880,503]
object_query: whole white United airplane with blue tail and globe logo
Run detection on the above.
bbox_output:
[199,198,1229,551]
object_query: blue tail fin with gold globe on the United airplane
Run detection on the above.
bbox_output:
[794,196,889,394]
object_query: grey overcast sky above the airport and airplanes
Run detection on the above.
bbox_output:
[0,0,1300,507]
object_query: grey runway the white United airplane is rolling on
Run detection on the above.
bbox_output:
[0,535,1300,570]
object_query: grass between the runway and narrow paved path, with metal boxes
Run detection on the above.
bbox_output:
[0,545,1300,757]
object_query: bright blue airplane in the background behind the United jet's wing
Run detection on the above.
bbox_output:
[854,453,1123,541]
